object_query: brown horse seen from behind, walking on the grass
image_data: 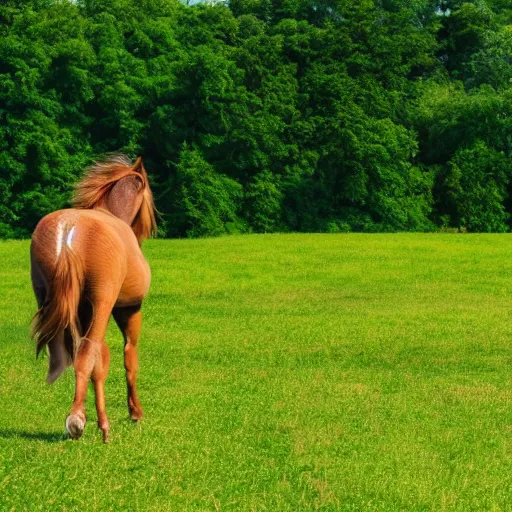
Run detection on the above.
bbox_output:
[30,156,156,442]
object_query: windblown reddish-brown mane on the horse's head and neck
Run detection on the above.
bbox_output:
[72,155,157,242]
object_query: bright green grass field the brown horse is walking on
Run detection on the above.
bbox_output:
[0,234,512,511]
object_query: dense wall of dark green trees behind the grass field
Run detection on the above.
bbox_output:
[0,0,512,237]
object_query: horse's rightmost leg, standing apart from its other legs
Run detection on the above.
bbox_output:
[113,304,142,421]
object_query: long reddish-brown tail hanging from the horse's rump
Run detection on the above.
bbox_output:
[32,244,84,382]
